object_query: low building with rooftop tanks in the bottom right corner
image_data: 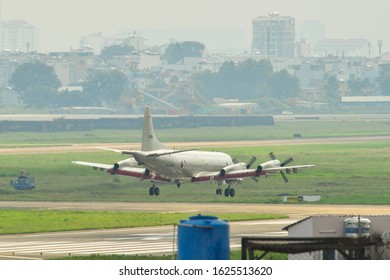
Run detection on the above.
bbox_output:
[283,215,390,260]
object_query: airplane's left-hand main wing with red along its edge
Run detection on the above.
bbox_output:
[72,161,171,183]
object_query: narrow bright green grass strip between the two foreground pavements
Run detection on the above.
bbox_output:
[0,210,287,235]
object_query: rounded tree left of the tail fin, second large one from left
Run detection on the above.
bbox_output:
[84,70,128,105]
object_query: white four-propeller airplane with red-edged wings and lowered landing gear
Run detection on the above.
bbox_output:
[72,105,314,197]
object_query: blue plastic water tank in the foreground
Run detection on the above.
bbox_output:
[177,215,230,260]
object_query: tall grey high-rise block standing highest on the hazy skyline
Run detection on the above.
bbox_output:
[252,12,295,57]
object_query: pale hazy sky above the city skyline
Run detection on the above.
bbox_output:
[0,0,390,52]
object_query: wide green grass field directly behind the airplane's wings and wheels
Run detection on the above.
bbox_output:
[0,137,390,204]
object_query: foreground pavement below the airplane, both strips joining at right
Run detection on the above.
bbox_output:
[0,201,390,259]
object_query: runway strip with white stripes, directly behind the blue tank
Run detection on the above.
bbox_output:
[0,219,293,259]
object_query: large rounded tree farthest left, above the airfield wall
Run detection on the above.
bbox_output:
[10,62,61,107]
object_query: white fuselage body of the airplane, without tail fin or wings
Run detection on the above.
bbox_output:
[133,150,233,179]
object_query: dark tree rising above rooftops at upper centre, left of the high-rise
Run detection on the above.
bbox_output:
[162,41,205,64]
